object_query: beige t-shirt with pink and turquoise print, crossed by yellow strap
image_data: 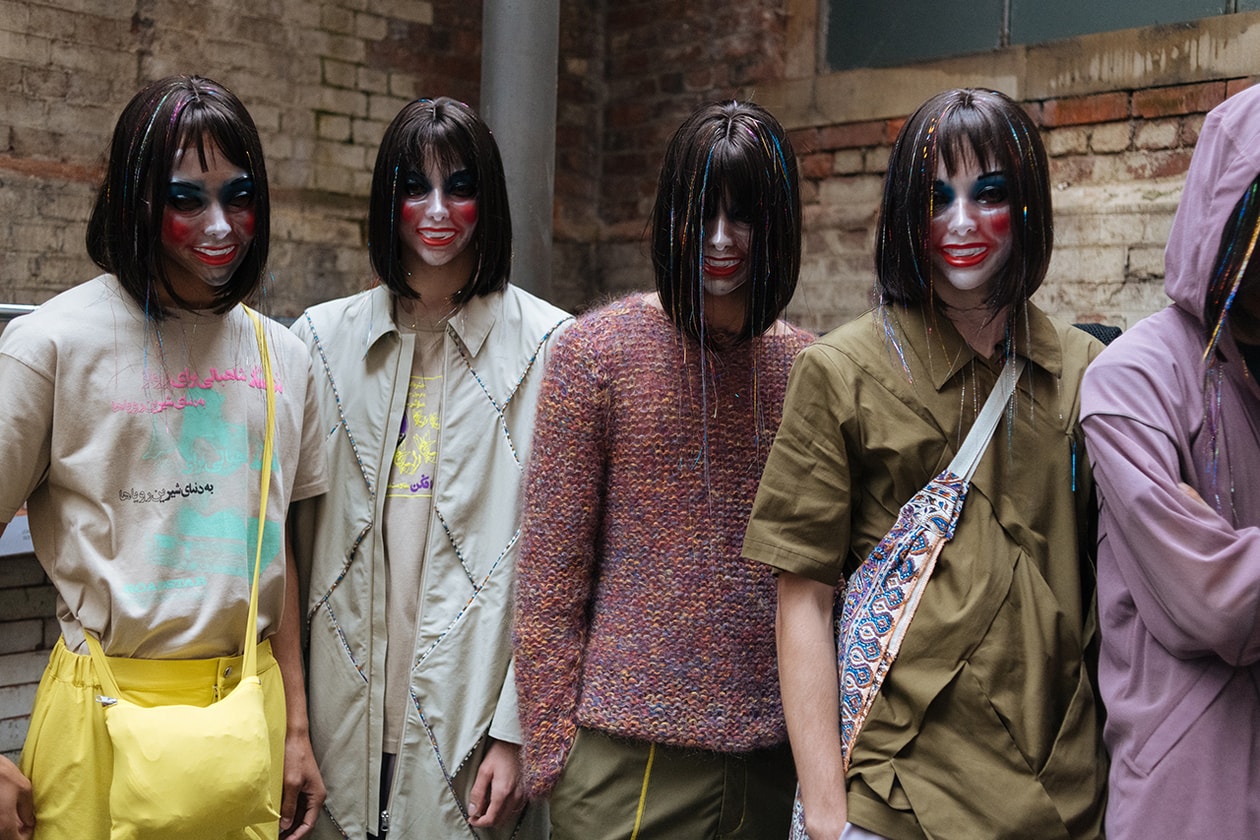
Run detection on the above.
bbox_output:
[0,275,328,659]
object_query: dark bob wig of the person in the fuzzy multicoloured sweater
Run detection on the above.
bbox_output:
[650,102,800,343]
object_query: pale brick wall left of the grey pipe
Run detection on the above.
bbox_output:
[0,0,491,316]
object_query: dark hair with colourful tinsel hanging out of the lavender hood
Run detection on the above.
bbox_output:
[1203,175,1260,513]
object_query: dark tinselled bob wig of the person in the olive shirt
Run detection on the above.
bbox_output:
[876,88,1055,311]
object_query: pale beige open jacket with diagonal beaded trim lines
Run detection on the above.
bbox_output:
[292,286,570,839]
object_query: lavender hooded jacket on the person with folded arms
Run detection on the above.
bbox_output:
[1081,87,1260,840]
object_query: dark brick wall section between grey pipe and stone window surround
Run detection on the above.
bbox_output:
[553,0,788,310]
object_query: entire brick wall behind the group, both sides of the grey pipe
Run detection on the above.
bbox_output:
[7,0,1229,330]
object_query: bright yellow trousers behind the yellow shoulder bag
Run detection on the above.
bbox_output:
[20,640,285,840]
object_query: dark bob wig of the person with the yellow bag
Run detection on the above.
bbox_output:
[87,76,271,320]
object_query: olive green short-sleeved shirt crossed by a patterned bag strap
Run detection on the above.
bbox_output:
[743,304,1106,840]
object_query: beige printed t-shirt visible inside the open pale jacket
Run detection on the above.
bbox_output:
[383,325,446,753]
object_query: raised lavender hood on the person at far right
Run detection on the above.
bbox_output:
[1164,86,1260,326]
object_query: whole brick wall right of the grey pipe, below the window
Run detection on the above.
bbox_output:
[546,0,1260,331]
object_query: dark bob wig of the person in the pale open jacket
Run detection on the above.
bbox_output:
[368,97,512,302]
